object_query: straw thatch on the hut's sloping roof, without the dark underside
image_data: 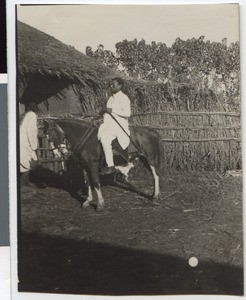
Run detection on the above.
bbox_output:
[17,21,117,86]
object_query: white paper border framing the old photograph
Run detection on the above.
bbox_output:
[6,0,246,300]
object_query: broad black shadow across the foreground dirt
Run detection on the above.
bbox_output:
[18,232,243,295]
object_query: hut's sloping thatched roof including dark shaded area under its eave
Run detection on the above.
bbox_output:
[17,21,118,103]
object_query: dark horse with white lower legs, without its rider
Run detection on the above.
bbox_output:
[44,119,161,211]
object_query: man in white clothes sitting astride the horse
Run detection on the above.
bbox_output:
[98,77,131,174]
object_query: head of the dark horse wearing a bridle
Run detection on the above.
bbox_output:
[43,120,70,158]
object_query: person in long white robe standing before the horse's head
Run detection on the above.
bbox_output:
[20,102,38,185]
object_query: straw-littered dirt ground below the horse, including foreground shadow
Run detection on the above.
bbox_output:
[19,168,243,295]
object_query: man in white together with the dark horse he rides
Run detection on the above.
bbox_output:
[44,78,161,211]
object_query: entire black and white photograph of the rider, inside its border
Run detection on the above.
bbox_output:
[11,2,244,296]
